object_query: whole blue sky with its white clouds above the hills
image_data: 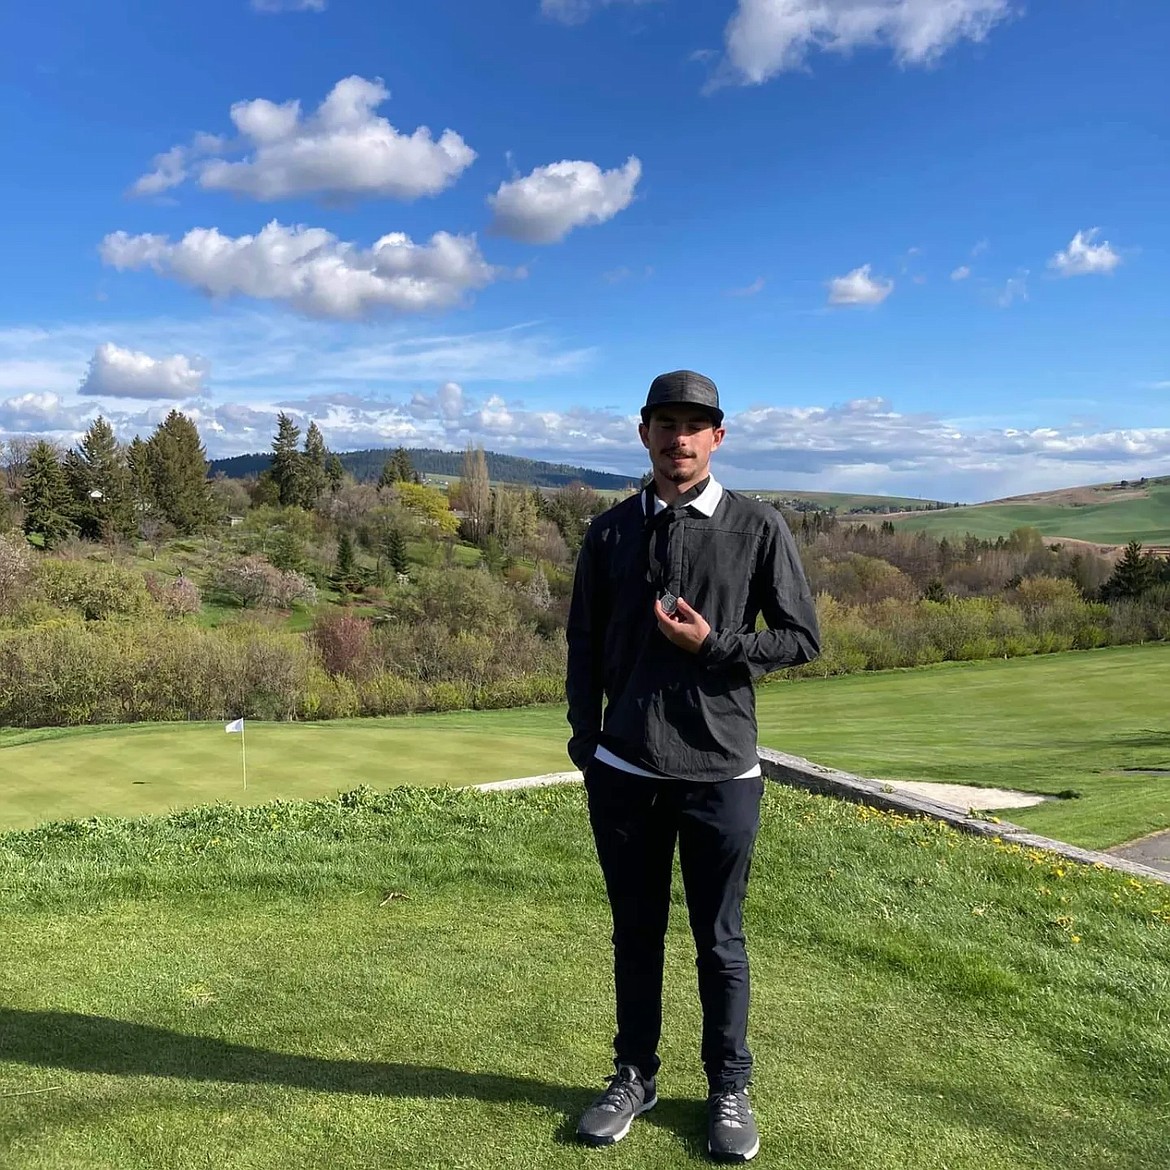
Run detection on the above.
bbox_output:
[0,0,1170,501]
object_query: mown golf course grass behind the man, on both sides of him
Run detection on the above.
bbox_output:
[0,645,1170,848]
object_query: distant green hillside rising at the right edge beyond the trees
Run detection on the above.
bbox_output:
[879,475,1170,549]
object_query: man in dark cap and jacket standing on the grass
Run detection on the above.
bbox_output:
[566,370,820,1162]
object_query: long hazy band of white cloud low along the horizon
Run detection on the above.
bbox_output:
[0,334,1170,500]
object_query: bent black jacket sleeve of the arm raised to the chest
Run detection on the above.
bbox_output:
[698,516,820,679]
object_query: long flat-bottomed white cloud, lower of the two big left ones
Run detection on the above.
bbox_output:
[101,220,502,317]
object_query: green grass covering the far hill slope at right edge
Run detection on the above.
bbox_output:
[893,483,1170,546]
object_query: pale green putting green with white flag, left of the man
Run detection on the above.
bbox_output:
[0,708,572,830]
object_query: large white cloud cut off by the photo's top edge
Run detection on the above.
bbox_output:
[723,0,1012,84]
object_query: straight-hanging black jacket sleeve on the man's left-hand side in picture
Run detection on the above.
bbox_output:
[565,525,606,769]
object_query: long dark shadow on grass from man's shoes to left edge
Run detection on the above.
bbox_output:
[0,1007,703,1148]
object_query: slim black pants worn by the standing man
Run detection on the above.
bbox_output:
[585,763,764,1090]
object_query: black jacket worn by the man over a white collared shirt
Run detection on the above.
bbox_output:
[566,479,820,780]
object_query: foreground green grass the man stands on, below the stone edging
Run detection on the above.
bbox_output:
[0,786,1170,1170]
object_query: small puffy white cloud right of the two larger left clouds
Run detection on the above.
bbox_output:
[488,156,642,243]
